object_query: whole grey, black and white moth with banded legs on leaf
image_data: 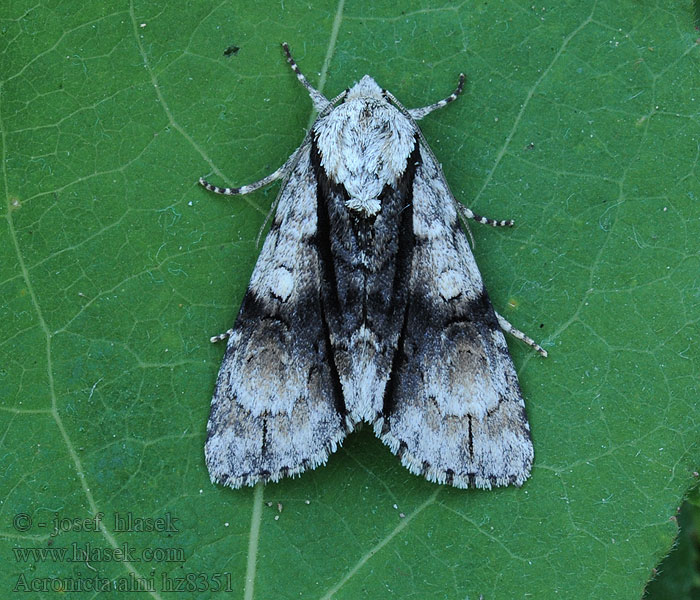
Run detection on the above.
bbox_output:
[200,43,547,488]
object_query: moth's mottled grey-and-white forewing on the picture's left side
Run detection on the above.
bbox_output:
[205,147,347,487]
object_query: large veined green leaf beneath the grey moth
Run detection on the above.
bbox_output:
[0,0,700,600]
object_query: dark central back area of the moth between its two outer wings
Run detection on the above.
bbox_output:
[311,140,418,423]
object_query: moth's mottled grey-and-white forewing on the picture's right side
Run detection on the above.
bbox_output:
[374,145,533,488]
